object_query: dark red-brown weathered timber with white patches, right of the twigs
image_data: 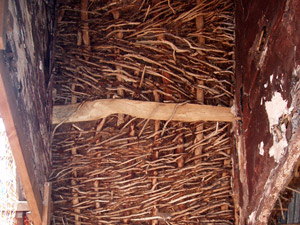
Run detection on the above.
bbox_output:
[234,0,300,225]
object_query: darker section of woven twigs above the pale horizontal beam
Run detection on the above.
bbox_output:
[54,0,234,106]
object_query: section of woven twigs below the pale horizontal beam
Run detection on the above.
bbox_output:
[52,118,233,224]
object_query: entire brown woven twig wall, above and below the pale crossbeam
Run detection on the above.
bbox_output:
[51,0,234,224]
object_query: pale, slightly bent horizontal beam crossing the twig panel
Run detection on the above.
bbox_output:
[52,99,234,124]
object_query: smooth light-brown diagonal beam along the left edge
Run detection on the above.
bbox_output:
[0,52,43,225]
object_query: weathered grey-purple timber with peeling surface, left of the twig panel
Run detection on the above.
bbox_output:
[0,0,53,200]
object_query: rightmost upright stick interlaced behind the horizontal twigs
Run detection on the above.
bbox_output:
[194,0,205,163]
